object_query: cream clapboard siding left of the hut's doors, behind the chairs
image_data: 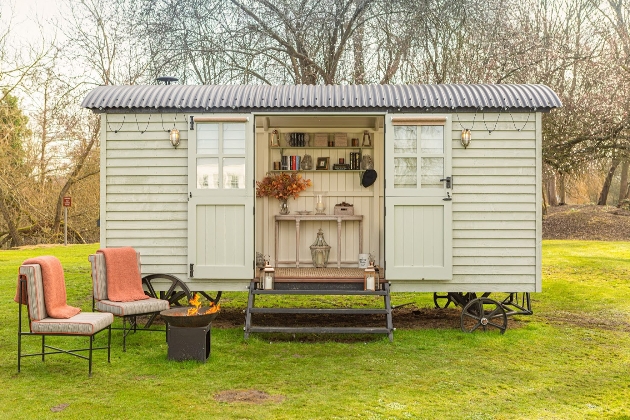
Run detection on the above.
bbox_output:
[101,113,188,279]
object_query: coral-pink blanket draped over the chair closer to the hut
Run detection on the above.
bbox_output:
[96,247,149,302]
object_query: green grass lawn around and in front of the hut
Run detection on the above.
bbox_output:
[0,241,630,419]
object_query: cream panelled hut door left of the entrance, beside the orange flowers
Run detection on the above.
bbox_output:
[187,115,254,279]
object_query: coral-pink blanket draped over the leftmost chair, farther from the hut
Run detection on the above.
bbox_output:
[15,255,81,318]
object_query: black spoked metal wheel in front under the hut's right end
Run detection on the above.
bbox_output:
[461,297,507,334]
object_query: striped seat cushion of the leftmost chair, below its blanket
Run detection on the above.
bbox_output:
[31,312,114,335]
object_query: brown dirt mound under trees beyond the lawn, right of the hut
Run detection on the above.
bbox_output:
[542,205,630,241]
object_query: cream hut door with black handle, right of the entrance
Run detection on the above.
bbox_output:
[385,115,453,280]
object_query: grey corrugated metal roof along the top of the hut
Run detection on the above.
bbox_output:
[81,84,562,112]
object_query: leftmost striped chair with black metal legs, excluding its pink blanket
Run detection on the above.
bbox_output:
[16,257,114,376]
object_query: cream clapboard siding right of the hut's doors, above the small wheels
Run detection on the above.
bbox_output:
[450,113,541,292]
